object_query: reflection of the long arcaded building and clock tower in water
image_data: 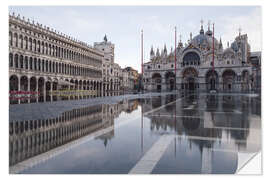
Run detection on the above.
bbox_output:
[9,100,138,166]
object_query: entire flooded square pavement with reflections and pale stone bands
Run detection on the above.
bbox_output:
[9,93,261,174]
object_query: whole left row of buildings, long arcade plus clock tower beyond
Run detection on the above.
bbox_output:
[9,13,141,104]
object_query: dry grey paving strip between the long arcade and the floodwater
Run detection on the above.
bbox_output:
[9,92,175,122]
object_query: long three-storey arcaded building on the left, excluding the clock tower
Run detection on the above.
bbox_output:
[9,14,104,103]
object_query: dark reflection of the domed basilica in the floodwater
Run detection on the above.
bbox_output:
[144,94,260,153]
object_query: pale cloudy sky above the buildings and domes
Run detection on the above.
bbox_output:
[9,6,262,72]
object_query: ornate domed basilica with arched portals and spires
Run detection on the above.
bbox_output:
[143,22,261,92]
